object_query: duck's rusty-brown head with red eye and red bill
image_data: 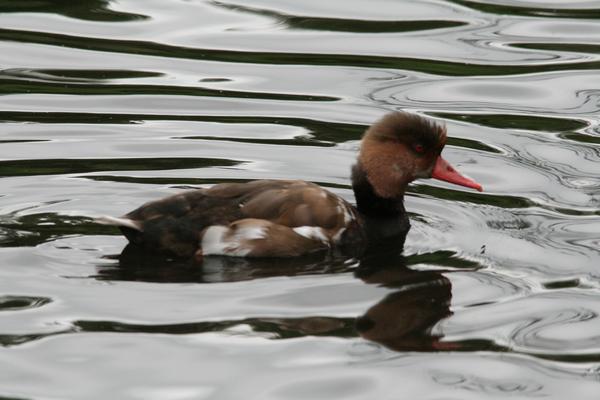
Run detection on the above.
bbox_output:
[358,112,483,198]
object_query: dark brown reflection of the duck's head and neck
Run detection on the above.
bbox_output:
[356,254,452,351]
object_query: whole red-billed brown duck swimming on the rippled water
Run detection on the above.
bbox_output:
[96,111,483,261]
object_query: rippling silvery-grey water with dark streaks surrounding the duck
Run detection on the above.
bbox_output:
[0,0,600,400]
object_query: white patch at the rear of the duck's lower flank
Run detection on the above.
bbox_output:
[201,225,266,257]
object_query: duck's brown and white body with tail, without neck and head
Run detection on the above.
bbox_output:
[98,180,356,257]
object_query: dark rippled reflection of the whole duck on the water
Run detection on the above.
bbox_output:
[96,242,453,351]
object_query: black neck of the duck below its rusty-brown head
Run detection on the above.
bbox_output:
[352,162,406,218]
